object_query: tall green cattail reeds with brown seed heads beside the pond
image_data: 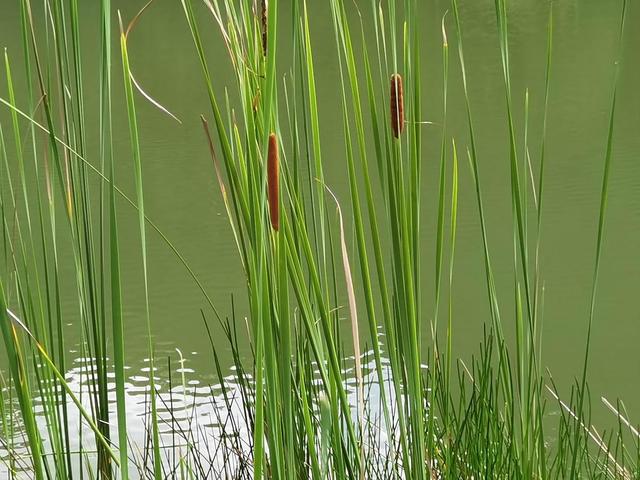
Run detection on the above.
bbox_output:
[0,0,640,480]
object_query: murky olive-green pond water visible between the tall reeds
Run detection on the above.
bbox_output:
[0,0,640,464]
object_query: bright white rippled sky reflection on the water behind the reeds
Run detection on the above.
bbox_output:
[0,344,396,479]
